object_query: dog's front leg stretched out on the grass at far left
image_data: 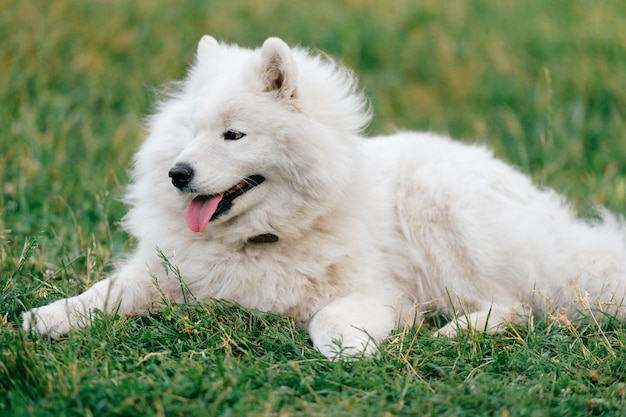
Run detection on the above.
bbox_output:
[22,250,158,338]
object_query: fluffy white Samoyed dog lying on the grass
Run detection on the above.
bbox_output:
[23,36,626,358]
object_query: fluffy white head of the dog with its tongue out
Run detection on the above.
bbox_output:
[128,36,369,244]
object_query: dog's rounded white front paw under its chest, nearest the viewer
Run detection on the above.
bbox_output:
[308,293,396,359]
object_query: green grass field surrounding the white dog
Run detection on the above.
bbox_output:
[0,0,626,416]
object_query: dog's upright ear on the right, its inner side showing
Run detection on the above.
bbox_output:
[261,38,298,98]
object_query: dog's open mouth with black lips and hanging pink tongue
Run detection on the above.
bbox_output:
[186,175,265,233]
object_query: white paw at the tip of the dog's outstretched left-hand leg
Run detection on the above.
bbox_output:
[22,300,82,339]
